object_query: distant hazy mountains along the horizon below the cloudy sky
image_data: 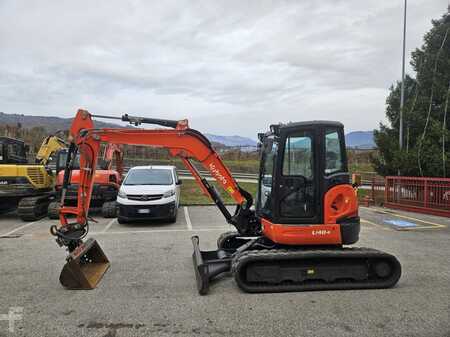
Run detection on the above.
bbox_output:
[0,112,375,149]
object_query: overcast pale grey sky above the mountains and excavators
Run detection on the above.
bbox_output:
[0,0,448,139]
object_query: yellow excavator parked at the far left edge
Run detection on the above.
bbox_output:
[0,135,67,221]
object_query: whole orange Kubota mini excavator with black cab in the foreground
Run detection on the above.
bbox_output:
[51,110,401,294]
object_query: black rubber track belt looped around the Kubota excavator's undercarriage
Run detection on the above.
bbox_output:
[231,248,401,293]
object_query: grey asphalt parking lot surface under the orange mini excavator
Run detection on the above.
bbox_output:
[0,206,450,337]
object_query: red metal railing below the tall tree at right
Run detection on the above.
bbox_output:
[384,176,450,217]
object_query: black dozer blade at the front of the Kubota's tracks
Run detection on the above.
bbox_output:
[191,236,233,295]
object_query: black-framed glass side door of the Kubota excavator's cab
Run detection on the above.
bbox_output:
[276,128,322,224]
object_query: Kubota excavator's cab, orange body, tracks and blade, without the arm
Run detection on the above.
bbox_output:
[192,121,401,295]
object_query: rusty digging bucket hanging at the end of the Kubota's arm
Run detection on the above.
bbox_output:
[59,239,110,290]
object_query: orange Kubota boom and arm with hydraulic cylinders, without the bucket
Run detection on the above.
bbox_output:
[52,110,260,250]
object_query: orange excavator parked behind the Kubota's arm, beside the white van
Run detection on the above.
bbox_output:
[48,143,123,219]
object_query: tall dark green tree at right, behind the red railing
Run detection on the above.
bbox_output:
[372,9,450,177]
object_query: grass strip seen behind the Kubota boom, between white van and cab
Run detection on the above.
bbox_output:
[180,179,258,205]
